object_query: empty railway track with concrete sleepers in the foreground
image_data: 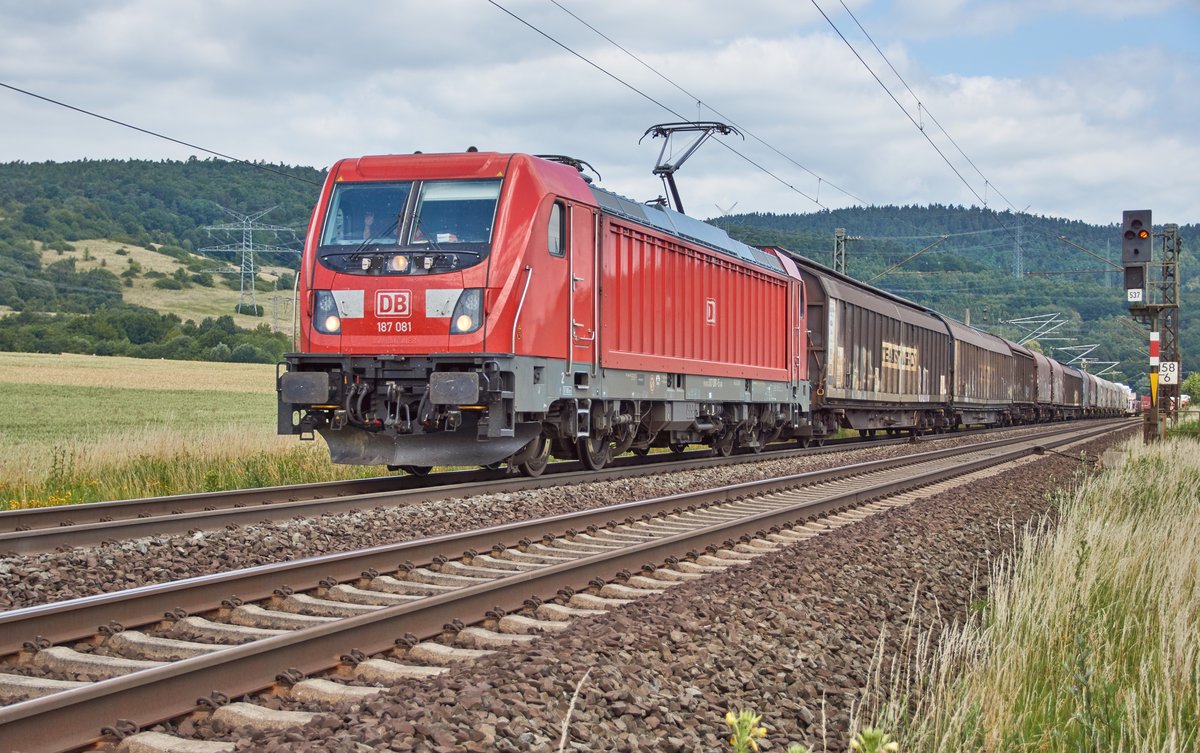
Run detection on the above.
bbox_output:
[0,422,1127,751]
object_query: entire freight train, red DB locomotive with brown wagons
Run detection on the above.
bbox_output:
[277,150,1124,475]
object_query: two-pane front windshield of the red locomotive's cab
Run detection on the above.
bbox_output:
[317,180,500,275]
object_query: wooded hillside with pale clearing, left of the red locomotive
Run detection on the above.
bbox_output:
[0,158,324,362]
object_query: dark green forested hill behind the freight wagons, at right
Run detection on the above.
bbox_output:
[710,205,1200,391]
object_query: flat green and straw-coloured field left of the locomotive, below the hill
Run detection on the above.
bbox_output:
[0,353,384,508]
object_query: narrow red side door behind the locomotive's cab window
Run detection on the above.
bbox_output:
[568,204,600,376]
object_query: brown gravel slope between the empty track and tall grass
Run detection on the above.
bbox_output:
[166,429,1114,753]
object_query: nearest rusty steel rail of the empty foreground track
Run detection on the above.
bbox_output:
[0,419,1122,753]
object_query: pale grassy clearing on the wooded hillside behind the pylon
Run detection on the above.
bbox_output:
[42,240,292,332]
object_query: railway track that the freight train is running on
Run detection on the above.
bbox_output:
[0,427,1104,554]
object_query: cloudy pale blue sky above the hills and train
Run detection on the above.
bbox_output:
[0,0,1200,224]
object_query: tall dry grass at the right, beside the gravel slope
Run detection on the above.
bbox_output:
[863,440,1200,753]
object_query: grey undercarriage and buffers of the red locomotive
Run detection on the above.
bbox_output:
[278,345,806,466]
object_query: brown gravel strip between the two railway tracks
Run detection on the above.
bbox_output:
[0,424,1113,610]
